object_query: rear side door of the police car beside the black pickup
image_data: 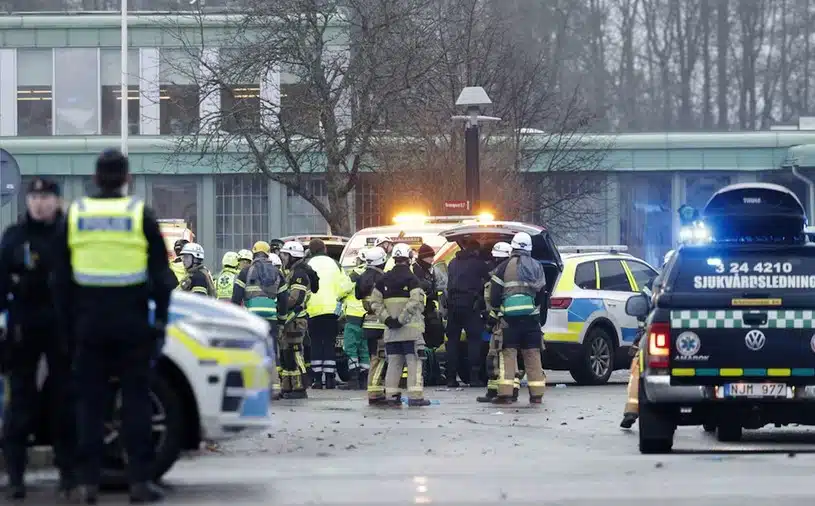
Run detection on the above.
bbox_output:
[597,258,637,346]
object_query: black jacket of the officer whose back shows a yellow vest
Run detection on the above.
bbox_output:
[54,192,177,339]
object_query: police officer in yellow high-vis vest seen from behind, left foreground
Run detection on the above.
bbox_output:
[54,149,175,504]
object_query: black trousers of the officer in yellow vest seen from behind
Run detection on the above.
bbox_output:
[75,336,155,485]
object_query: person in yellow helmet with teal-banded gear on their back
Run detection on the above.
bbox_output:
[232,241,289,400]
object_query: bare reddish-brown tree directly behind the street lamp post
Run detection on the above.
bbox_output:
[376,0,608,234]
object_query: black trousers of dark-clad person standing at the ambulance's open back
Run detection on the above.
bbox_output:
[446,307,487,382]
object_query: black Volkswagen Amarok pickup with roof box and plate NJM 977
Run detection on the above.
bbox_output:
[626,184,815,453]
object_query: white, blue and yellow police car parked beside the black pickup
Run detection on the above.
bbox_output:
[543,246,657,385]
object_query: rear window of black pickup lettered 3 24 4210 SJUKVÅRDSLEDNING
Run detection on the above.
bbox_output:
[670,246,815,293]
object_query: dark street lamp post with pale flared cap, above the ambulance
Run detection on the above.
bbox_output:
[452,86,501,212]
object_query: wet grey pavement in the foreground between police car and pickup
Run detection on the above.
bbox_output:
[7,372,815,506]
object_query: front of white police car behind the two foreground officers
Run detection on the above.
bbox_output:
[0,291,274,485]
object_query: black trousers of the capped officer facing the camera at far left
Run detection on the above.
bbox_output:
[3,328,76,485]
